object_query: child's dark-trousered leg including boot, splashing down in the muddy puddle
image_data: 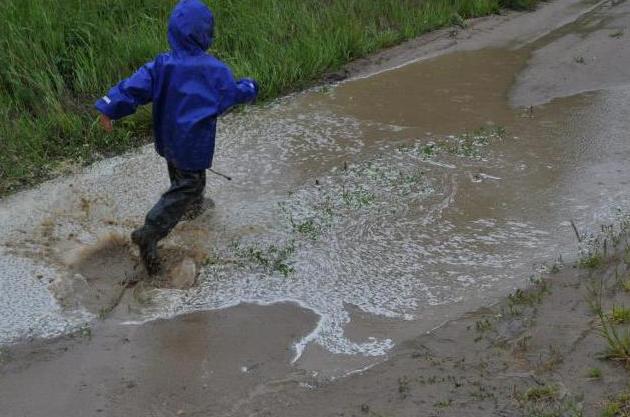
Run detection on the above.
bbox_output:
[132,163,206,274]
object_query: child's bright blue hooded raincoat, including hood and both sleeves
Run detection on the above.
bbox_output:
[95,0,258,171]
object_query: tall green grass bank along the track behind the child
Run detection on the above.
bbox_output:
[0,0,538,195]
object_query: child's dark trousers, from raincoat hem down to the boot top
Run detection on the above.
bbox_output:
[144,162,206,240]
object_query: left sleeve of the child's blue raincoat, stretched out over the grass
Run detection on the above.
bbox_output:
[95,62,155,120]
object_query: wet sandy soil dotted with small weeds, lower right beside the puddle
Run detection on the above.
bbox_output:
[228,248,630,417]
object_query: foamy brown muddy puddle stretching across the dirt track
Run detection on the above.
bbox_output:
[0,0,630,376]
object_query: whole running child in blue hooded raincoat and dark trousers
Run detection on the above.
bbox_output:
[96,0,258,275]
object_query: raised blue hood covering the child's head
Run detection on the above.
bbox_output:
[168,0,214,54]
